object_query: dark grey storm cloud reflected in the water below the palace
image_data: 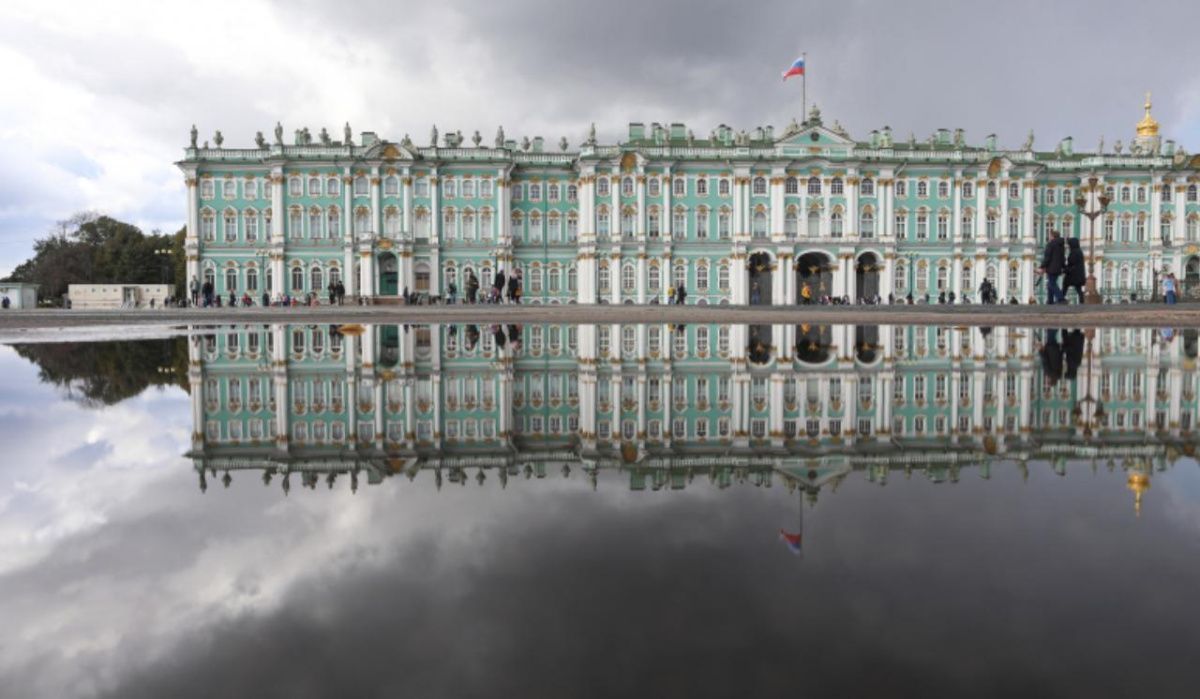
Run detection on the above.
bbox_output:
[87,468,1198,699]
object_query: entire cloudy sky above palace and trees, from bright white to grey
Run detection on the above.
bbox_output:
[0,0,1200,275]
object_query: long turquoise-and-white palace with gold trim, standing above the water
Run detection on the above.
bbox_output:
[178,96,1200,304]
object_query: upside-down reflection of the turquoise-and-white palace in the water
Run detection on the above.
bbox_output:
[190,324,1198,514]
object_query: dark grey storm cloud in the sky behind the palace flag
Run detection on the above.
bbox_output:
[274,0,1200,149]
